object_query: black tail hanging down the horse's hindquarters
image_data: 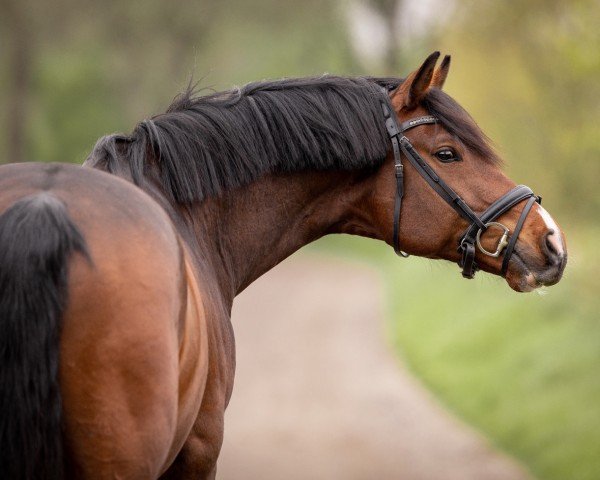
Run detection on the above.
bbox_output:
[0,192,89,480]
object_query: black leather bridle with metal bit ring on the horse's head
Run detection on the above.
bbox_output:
[381,88,542,278]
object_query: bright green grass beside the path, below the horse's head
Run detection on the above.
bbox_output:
[311,231,600,480]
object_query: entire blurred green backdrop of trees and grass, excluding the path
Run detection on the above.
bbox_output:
[0,0,600,480]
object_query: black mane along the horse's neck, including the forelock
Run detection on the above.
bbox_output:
[86,75,493,203]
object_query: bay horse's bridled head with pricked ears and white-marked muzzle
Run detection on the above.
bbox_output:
[377,52,567,292]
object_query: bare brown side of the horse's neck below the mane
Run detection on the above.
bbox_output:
[183,172,377,300]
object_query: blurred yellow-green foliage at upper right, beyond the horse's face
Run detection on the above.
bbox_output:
[435,0,600,225]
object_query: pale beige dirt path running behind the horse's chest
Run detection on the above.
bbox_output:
[217,254,528,480]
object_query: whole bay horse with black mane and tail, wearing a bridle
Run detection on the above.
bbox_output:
[0,52,567,480]
